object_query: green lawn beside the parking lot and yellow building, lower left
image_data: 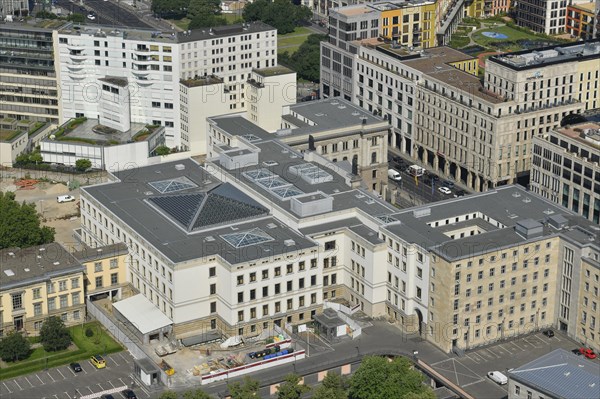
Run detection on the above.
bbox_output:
[0,322,123,380]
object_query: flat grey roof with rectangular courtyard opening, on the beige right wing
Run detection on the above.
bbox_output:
[384,185,600,260]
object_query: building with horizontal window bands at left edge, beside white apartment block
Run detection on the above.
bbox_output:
[0,19,64,124]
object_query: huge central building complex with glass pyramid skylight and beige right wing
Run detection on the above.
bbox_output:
[81,121,600,352]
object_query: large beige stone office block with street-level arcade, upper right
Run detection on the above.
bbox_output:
[321,39,600,191]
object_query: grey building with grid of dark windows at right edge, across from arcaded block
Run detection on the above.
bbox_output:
[530,122,600,224]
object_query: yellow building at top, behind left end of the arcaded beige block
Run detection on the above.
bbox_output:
[380,1,436,48]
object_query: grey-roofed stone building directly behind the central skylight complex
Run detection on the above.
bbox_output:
[207,98,388,195]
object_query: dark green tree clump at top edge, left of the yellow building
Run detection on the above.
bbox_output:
[243,0,312,34]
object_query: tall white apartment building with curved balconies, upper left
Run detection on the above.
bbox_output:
[55,22,277,150]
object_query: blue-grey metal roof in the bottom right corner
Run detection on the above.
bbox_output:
[508,349,600,399]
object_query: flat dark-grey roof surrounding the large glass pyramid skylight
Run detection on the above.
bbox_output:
[82,159,317,264]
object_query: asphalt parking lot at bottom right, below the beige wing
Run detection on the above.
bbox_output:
[431,331,598,399]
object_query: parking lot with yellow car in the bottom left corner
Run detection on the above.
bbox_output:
[0,352,150,399]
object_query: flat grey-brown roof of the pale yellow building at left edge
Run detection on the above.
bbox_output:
[0,242,84,290]
